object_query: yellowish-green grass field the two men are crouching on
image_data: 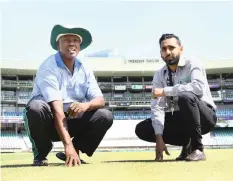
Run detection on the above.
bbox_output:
[1,149,233,181]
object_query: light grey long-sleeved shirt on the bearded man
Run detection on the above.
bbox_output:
[151,57,216,135]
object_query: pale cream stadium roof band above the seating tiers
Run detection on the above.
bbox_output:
[1,57,233,76]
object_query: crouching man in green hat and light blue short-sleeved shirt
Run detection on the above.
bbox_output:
[24,25,113,166]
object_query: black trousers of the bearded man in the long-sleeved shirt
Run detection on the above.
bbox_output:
[135,92,217,151]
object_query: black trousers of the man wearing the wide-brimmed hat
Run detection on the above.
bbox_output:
[24,100,113,159]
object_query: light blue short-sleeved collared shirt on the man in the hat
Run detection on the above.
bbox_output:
[30,52,103,111]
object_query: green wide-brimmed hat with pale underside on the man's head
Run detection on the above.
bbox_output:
[50,25,92,51]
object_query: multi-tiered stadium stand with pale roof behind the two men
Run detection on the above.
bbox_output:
[0,57,233,151]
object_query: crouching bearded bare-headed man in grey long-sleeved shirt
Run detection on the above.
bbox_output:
[135,34,217,161]
